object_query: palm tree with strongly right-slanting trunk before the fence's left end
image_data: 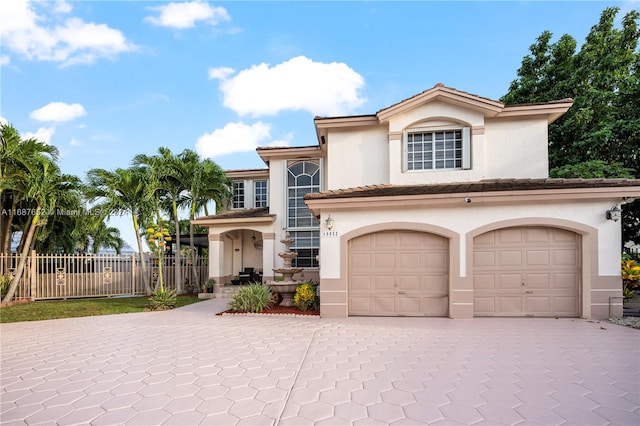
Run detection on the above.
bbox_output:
[3,161,79,302]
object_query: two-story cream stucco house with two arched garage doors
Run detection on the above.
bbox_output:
[195,84,640,318]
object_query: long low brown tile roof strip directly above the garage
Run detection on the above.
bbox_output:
[304,179,640,200]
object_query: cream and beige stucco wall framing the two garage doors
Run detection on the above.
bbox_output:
[320,199,621,318]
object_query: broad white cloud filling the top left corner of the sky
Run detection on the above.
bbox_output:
[0,0,137,66]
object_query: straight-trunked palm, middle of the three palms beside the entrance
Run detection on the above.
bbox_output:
[133,147,186,293]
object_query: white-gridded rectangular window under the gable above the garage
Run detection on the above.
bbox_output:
[404,127,471,171]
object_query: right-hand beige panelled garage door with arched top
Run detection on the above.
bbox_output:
[473,227,580,317]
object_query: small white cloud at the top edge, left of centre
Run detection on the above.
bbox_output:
[145,1,231,29]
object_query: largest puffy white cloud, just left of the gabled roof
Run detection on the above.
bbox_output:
[220,56,366,116]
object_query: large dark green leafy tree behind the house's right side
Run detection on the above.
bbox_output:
[502,7,640,241]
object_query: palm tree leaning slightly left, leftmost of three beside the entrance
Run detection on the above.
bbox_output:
[86,167,155,294]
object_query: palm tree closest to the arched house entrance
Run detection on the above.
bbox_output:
[179,149,231,283]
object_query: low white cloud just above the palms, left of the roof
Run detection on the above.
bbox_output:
[196,121,282,158]
